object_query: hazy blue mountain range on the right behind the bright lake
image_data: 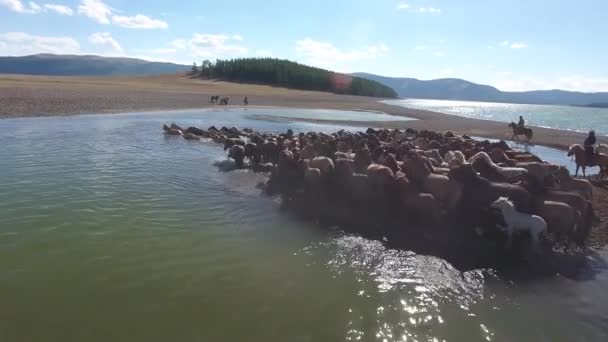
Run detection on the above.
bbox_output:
[353,73,608,106]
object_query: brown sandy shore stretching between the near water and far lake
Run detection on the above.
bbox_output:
[0,75,608,149]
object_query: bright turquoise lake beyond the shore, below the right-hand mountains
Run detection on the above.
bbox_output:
[384,99,608,135]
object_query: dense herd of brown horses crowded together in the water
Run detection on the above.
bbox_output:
[163,124,595,267]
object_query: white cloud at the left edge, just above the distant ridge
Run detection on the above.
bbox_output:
[0,32,80,56]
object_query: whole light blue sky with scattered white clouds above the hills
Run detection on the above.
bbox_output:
[0,0,608,91]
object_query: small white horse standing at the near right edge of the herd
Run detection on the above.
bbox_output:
[490,197,547,251]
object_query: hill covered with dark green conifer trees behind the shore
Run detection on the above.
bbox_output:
[192,58,398,98]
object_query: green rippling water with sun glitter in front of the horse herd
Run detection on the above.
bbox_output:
[0,109,608,342]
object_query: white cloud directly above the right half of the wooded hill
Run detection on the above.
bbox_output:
[296,38,388,68]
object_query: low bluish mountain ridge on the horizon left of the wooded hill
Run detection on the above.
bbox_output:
[0,54,192,76]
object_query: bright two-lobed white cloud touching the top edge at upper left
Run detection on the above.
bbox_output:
[78,0,169,29]
